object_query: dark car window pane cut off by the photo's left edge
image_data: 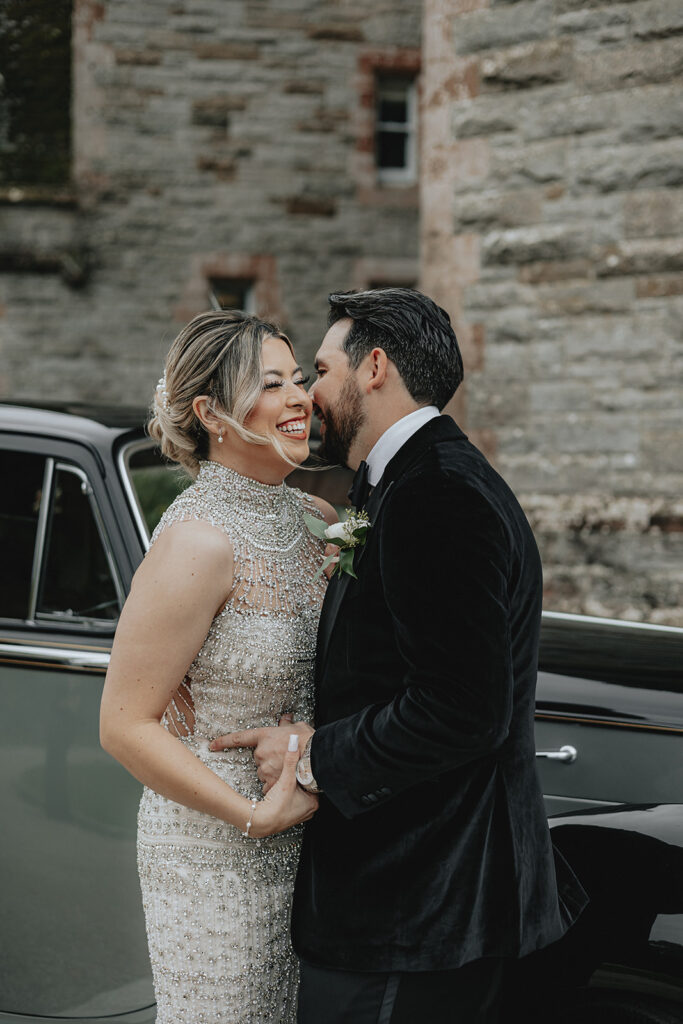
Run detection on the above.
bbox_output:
[0,452,45,618]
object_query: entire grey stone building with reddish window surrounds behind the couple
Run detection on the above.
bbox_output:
[0,0,683,625]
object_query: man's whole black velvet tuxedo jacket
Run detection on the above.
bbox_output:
[293,416,583,971]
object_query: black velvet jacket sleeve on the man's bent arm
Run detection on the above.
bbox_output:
[311,474,513,818]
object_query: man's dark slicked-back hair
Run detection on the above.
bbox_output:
[328,288,463,410]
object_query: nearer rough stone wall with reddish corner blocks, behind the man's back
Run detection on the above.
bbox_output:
[421,0,683,625]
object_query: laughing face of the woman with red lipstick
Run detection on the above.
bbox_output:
[245,337,312,463]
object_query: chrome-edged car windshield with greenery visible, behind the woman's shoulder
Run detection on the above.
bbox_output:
[122,441,191,540]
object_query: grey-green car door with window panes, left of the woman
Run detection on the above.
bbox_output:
[0,434,154,1021]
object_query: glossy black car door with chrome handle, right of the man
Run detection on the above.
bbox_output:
[536,614,683,814]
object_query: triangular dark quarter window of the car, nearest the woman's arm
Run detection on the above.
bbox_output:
[36,469,119,620]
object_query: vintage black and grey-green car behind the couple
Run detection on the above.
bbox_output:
[0,403,683,1024]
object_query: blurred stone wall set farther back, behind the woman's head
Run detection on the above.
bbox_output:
[0,0,421,402]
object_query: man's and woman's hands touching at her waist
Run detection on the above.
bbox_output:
[209,714,317,838]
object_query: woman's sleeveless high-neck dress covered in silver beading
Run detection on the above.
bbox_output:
[137,462,327,1024]
